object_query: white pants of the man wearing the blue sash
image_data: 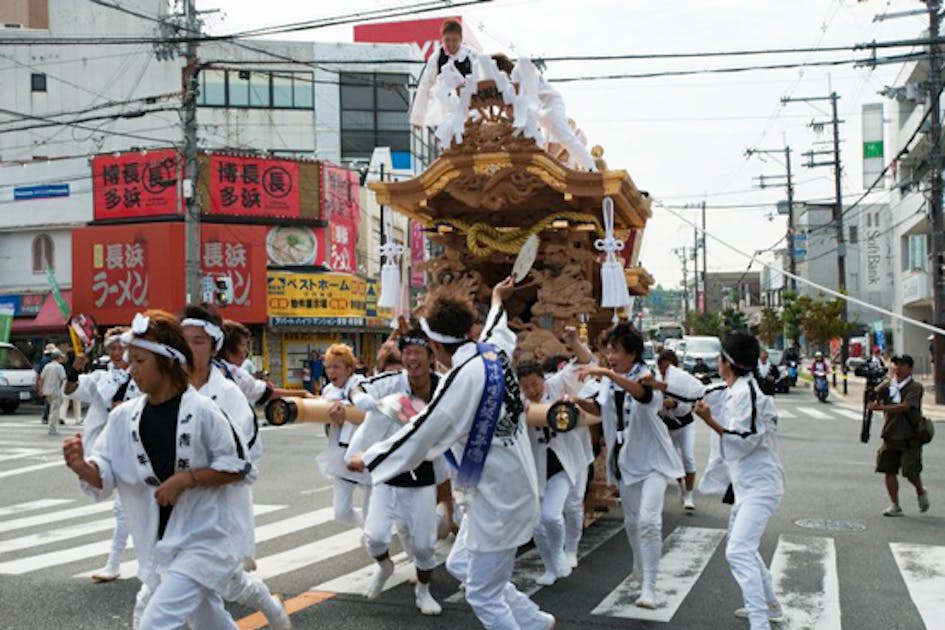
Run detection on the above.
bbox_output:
[446,526,548,630]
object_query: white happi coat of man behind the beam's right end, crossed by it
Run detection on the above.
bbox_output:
[528,361,594,495]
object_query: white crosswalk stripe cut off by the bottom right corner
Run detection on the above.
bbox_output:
[889,543,945,628]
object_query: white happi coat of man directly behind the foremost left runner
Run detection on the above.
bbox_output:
[197,366,262,558]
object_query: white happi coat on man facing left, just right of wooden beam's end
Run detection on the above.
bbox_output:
[581,364,685,485]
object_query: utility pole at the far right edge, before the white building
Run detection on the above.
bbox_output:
[926,0,945,405]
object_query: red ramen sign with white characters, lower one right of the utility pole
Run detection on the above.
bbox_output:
[200,223,266,324]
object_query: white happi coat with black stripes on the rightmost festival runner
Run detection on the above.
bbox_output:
[716,375,784,505]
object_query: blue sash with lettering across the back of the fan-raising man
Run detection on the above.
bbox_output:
[446,343,505,488]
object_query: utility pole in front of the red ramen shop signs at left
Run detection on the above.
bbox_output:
[183,0,203,302]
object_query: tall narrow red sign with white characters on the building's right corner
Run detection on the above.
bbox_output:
[321,162,360,273]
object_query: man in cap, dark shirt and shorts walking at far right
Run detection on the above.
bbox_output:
[870,354,929,516]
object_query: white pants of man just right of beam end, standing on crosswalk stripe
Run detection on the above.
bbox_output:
[620,473,666,590]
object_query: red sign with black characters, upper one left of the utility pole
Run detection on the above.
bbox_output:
[92,149,179,221]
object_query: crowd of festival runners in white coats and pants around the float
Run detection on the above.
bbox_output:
[55,279,784,630]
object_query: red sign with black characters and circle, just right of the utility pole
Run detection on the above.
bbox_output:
[209,154,300,218]
